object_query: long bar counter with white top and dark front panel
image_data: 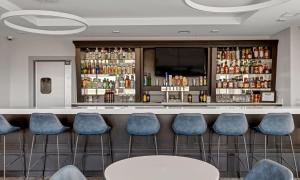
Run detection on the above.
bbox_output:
[0,104,300,177]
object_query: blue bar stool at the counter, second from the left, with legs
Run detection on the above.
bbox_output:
[26,113,69,179]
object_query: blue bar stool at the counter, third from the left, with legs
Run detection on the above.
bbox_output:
[73,113,113,175]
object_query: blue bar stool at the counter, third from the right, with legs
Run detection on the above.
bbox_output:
[172,113,207,161]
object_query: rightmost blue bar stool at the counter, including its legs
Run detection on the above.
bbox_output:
[252,113,298,179]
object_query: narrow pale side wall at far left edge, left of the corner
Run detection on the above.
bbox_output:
[0,37,10,107]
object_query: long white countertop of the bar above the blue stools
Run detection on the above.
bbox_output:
[0,105,300,114]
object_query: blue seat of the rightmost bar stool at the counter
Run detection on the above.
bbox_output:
[257,113,295,136]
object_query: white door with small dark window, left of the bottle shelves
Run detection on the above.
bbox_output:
[35,61,65,107]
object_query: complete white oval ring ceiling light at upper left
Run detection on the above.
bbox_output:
[0,10,88,35]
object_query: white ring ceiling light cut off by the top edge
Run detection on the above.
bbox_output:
[184,0,290,13]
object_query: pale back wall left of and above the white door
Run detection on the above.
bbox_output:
[6,38,75,107]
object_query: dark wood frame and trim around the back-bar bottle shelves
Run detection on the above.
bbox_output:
[73,40,279,102]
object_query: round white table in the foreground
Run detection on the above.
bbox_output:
[104,156,220,180]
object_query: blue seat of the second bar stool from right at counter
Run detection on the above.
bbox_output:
[213,113,248,136]
